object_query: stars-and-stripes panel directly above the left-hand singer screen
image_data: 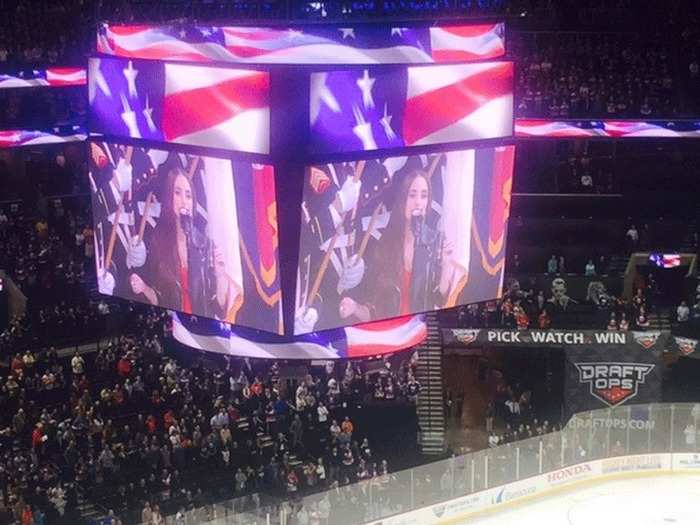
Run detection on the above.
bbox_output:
[88,58,270,153]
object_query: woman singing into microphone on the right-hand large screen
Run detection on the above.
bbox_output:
[339,170,454,322]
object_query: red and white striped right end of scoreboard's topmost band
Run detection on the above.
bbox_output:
[430,23,506,62]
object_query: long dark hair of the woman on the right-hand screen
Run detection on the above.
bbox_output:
[373,170,433,306]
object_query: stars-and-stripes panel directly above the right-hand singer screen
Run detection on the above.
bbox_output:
[309,62,513,152]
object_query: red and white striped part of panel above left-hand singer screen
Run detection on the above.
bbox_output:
[162,64,270,153]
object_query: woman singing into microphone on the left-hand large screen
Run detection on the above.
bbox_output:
[129,168,241,318]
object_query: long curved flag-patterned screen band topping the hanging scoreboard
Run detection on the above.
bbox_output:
[97,23,505,64]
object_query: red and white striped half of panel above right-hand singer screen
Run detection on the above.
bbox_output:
[403,62,513,146]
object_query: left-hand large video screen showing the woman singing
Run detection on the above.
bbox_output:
[89,142,282,333]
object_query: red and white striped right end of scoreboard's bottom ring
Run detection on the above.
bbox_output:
[345,315,428,358]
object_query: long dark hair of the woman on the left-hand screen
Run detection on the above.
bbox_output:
[149,167,197,300]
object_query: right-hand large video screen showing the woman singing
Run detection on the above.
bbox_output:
[294,146,514,334]
